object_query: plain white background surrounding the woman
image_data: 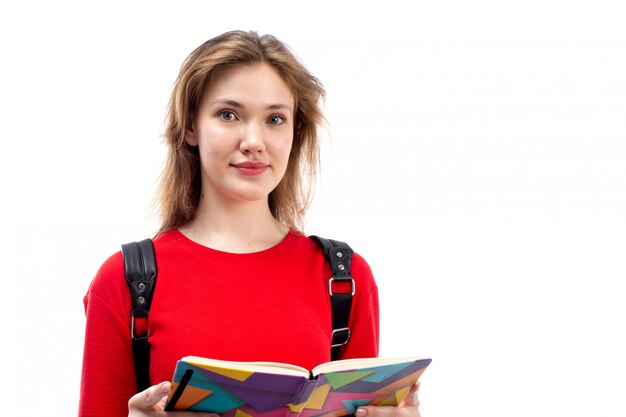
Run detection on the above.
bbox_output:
[0,0,626,417]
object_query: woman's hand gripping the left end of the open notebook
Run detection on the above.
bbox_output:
[128,382,219,417]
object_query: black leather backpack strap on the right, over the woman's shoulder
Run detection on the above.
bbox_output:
[309,236,355,360]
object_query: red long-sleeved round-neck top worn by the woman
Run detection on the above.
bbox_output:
[79,230,379,417]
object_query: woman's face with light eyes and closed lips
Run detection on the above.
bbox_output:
[185,63,294,205]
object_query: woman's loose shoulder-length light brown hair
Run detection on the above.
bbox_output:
[156,31,325,236]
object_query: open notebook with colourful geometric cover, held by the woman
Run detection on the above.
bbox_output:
[166,356,431,417]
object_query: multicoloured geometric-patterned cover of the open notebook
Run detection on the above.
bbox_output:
[168,361,429,417]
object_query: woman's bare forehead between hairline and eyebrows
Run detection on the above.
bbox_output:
[205,62,294,108]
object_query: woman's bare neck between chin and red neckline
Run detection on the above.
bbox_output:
[180,192,289,253]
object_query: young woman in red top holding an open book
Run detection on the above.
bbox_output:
[80,31,419,417]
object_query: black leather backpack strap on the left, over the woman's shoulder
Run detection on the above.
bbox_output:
[122,239,157,391]
